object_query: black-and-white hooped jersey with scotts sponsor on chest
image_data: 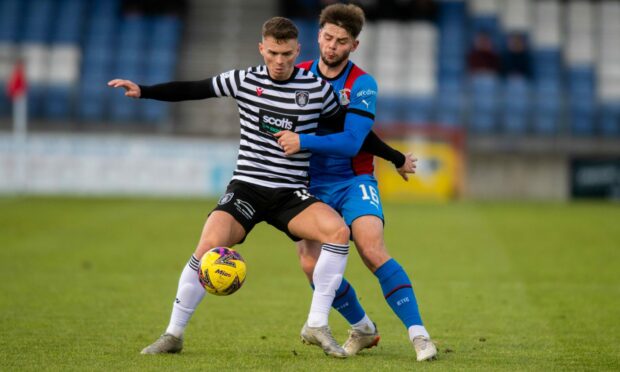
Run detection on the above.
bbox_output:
[211,65,340,188]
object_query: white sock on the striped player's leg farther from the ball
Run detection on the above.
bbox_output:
[308,243,349,327]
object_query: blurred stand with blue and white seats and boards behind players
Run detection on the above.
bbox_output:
[0,0,620,200]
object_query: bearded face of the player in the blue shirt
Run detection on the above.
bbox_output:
[319,23,359,67]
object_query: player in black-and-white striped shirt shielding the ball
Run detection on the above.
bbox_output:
[108,17,400,358]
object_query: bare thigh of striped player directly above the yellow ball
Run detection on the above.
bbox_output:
[195,210,246,259]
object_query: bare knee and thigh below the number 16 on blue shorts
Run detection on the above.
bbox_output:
[351,215,390,272]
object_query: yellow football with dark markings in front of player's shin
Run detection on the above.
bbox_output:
[198,247,246,296]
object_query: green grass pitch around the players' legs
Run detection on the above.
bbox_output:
[0,197,620,371]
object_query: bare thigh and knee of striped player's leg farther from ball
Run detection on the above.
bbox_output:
[288,202,350,244]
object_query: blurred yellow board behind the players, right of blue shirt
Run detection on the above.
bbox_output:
[375,138,462,201]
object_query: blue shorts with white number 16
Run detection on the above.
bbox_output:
[310,174,383,226]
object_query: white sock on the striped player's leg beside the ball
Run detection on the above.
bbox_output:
[166,255,206,338]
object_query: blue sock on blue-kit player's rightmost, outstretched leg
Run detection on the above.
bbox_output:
[375,258,423,329]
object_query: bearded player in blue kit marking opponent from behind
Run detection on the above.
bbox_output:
[276,4,437,361]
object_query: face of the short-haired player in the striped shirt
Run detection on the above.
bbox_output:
[258,36,299,80]
